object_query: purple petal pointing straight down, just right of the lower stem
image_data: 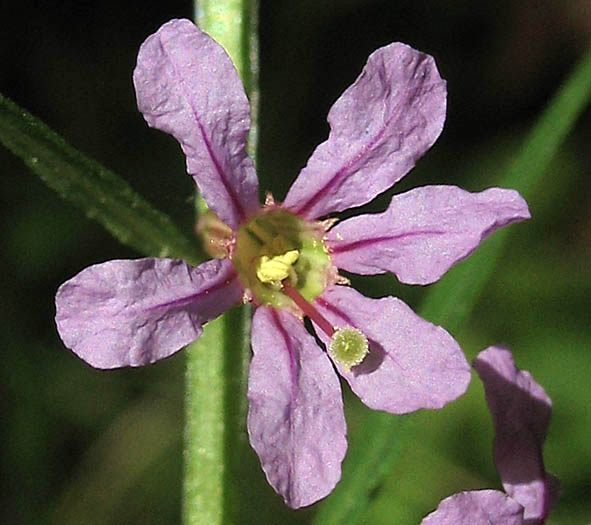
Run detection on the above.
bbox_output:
[248,307,347,508]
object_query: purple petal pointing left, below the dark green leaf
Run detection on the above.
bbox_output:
[55,258,242,368]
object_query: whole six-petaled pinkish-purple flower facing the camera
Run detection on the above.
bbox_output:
[56,20,529,508]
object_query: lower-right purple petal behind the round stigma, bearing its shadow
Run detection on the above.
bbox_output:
[315,286,470,414]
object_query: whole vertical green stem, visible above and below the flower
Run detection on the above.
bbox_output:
[183,0,258,525]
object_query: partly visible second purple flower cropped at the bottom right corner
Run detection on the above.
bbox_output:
[422,346,559,525]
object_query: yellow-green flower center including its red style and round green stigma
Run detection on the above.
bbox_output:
[230,206,368,371]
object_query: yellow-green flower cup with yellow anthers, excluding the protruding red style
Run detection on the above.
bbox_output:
[231,207,337,311]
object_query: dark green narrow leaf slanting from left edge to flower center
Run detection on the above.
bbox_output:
[0,95,203,263]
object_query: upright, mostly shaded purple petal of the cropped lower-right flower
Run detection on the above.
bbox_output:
[473,346,559,521]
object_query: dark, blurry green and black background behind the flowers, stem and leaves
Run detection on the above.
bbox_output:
[0,0,591,524]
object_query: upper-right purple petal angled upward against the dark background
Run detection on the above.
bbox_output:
[284,43,446,219]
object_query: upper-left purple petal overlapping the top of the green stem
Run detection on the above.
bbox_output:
[133,20,259,229]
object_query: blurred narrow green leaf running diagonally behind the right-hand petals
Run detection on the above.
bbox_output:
[314,46,591,525]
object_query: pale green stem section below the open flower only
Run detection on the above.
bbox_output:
[183,306,250,525]
